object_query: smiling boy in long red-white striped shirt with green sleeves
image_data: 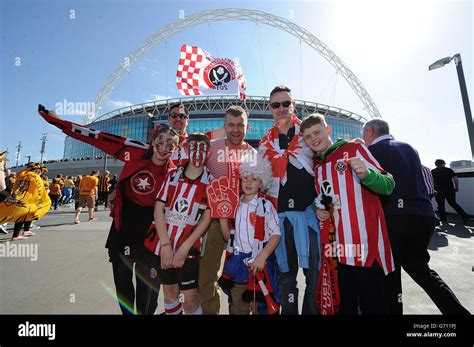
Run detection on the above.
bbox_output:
[300,114,395,314]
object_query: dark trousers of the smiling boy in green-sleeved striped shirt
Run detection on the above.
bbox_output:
[337,262,386,315]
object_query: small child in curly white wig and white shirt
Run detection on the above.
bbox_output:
[218,155,281,314]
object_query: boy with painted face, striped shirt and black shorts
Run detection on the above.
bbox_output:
[151,133,213,315]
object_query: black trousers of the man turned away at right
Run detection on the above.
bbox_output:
[385,215,469,314]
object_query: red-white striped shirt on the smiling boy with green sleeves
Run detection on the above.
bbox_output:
[315,142,394,274]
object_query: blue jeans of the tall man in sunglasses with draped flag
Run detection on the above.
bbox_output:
[278,218,319,315]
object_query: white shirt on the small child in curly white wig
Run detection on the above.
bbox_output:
[234,196,281,253]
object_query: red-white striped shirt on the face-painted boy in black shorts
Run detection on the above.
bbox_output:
[155,166,213,255]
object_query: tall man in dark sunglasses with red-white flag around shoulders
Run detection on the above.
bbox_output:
[258,86,320,314]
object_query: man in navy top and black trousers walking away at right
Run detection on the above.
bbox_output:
[363,119,469,314]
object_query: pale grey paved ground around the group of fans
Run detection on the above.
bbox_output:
[0,207,474,314]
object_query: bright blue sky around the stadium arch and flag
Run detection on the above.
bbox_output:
[0,0,474,167]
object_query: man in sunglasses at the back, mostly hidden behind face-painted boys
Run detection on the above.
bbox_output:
[168,103,225,166]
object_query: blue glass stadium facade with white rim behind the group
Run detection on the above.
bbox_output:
[63,96,365,159]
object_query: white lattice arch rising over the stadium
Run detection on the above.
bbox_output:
[84,8,380,123]
